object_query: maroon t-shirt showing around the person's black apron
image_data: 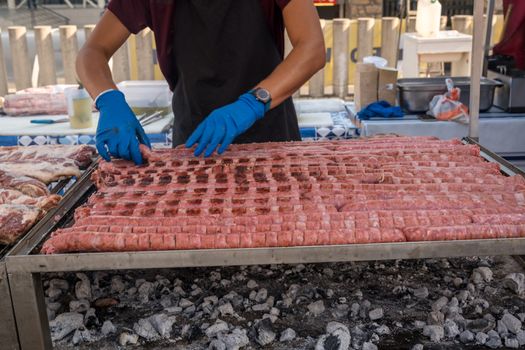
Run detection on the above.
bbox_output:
[108,0,291,90]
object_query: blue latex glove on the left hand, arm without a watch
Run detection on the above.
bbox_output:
[96,90,151,165]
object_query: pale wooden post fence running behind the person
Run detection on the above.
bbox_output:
[0,16,503,97]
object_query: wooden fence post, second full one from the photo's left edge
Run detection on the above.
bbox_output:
[34,26,57,86]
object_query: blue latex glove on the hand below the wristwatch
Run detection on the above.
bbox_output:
[186,93,265,157]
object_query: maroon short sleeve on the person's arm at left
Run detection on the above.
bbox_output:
[108,0,151,34]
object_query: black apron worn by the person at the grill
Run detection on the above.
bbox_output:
[173,0,301,147]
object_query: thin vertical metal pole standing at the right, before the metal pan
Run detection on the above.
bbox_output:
[469,0,485,140]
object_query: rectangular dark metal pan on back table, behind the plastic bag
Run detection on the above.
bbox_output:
[397,77,503,113]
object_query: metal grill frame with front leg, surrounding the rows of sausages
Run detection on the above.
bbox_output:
[7,139,525,350]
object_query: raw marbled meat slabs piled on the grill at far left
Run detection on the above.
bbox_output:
[0,145,95,244]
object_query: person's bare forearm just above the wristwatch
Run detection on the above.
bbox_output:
[257,42,325,108]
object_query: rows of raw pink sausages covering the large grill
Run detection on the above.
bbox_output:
[42,136,525,254]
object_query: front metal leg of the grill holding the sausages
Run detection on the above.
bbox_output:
[9,272,53,350]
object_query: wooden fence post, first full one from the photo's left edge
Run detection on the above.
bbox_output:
[7,26,31,90]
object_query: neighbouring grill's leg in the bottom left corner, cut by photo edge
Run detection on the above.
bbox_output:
[0,263,20,350]
